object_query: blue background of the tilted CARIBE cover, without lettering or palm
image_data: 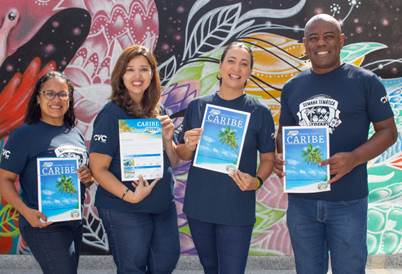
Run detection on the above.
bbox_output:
[198,108,247,164]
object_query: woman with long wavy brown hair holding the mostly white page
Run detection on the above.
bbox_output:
[89,45,180,274]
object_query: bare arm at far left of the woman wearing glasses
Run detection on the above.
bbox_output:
[0,168,51,228]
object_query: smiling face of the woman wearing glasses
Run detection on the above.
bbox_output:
[37,77,70,126]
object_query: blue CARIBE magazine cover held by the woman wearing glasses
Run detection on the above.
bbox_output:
[37,158,81,222]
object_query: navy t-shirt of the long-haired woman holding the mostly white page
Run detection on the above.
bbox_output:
[90,102,173,213]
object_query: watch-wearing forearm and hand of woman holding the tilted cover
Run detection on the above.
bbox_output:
[229,152,274,191]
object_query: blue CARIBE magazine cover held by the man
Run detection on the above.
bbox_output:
[282,126,331,193]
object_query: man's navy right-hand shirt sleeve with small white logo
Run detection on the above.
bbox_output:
[367,75,394,123]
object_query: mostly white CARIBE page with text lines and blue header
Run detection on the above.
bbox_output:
[119,118,163,181]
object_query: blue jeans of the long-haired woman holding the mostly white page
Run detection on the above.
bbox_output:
[98,203,180,274]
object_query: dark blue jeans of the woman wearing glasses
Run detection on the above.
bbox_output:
[20,215,82,274]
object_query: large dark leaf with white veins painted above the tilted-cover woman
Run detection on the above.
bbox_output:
[183,3,241,60]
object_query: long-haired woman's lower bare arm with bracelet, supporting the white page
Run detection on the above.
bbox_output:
[89,152,158,204]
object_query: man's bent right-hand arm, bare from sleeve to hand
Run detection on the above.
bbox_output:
[321,118,398,183]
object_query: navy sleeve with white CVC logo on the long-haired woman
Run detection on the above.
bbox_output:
[89,109,119,157]
